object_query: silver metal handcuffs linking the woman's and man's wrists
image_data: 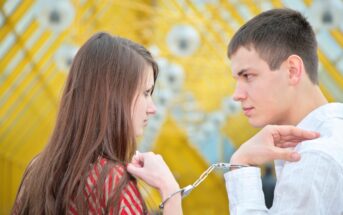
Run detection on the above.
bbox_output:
[159,163,249,210]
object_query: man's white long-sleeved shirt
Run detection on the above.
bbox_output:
[224,103,343,215]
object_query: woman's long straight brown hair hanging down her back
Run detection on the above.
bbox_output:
[12,33,158,214]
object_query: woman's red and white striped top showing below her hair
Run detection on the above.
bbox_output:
[69,158,144,215]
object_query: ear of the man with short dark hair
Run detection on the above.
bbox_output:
[286,55,304,85]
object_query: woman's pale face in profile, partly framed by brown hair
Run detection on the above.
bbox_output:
[131,66,156,137]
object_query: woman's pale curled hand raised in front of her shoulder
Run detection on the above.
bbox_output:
[127,152,180,199]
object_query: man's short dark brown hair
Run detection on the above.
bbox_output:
[228,9,318,84]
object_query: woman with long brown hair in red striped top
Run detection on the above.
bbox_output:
[12,33,181,214]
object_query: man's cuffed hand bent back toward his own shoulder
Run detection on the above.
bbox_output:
[231,125,320,166]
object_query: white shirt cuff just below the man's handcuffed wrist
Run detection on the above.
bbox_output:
[224,167,265,209]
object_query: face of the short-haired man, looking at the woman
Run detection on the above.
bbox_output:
[231,47,292,127]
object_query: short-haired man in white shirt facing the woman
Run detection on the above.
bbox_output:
[225,9,343,215]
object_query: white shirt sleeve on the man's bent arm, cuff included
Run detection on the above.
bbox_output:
[225,151,343,215]
